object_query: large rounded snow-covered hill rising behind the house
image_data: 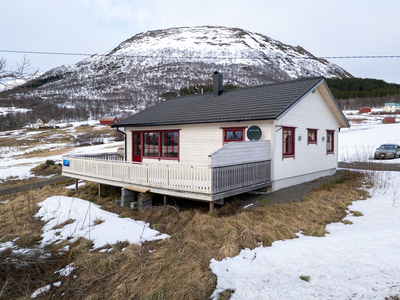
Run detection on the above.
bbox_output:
[3,26,351,109]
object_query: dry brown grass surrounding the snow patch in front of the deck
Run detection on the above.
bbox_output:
[0,172,368,299]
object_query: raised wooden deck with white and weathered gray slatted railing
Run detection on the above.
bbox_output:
[63,153,271,201]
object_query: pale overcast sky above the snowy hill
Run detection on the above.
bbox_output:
[0,0,400,83]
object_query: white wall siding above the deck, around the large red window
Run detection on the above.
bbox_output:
[126,120,273,166]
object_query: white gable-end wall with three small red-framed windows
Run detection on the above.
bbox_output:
[272,89,339,189]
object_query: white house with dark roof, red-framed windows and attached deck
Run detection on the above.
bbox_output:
[63,72,350,212]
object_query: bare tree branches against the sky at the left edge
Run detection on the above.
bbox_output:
[0,56,38,87]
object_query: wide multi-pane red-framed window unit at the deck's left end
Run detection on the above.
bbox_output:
[132,130,179,162]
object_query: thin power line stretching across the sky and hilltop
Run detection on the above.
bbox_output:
[0,49,400,60]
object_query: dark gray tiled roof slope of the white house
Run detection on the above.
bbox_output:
[112,77,323,127]
